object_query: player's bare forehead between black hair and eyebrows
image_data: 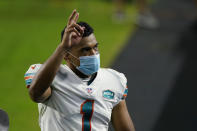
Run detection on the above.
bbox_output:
[76,34,97,48]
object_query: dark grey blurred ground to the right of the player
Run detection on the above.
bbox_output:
[112,0,197,131]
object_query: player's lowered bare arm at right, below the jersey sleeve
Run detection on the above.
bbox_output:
[112,100,135,131]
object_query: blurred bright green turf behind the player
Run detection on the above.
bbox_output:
[0,0,136,131]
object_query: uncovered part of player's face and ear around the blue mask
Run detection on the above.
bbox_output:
[66,34,99,66]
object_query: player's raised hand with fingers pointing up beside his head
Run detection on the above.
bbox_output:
[61,10,85,50]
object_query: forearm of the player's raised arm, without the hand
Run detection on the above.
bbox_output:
[29,45,65,101]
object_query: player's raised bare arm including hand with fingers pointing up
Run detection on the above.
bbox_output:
[29,10,84,102]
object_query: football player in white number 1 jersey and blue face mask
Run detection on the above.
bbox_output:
[25,10,134,131]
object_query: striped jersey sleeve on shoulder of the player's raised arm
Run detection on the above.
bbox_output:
[24,64,41,88]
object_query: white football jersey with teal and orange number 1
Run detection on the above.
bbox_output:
[25,64,128,131]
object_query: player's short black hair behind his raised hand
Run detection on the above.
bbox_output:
[61,21,94,41]
